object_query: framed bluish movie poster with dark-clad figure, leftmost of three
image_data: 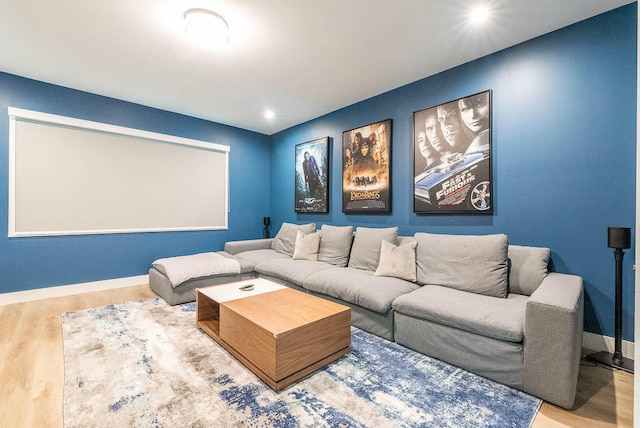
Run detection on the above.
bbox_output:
[295,137,329,213]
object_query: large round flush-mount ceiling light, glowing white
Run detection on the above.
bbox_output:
[184,9,229,47]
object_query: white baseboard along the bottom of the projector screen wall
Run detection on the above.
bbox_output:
[0,275,149,306]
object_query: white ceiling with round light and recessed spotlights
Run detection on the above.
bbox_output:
[0,0,634,134]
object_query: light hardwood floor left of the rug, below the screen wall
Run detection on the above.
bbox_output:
[0,285,155,428]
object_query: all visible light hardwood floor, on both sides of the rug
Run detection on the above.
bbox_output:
[0,284,633,428]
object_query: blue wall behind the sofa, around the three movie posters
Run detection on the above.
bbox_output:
[271,3,637,341]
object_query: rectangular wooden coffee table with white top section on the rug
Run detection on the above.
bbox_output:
[196,278,351,391]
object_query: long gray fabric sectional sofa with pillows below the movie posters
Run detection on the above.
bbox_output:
[150,223,584,408]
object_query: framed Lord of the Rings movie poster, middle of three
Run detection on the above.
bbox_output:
[342,119,391,214]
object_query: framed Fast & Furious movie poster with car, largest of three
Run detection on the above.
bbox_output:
[413,90,493,214]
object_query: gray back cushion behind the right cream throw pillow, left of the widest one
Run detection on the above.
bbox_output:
[349,227,398,272]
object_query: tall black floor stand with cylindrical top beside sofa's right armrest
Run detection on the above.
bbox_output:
[589,227,633,373]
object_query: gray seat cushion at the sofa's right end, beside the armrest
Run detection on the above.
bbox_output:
[393,285,528,343]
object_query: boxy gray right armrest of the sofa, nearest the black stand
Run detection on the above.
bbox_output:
[523,273,584,409]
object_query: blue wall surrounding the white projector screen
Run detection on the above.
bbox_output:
[0,73,270,293]
